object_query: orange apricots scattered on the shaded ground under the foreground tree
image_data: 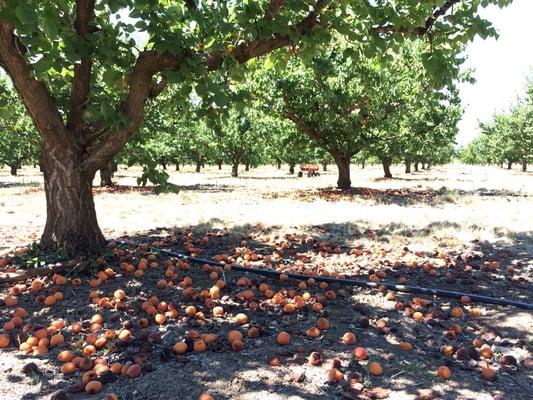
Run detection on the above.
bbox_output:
[0,229,533,400]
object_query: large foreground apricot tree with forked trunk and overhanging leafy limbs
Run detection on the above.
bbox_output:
[0,0,510,254]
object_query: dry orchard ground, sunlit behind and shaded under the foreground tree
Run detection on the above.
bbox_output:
[0,164,533,400]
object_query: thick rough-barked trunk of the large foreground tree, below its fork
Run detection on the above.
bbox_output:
[41,146,106,255]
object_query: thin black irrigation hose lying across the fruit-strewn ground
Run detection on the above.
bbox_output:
[118,241,533,310]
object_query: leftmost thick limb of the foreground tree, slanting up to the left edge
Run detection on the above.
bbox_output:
[0,21,67,144]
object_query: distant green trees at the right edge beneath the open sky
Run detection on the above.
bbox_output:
[460,81,533,171]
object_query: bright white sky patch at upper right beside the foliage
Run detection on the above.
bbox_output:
[457,0,533,145]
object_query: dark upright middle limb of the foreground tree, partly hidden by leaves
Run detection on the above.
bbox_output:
[67,0,95,134]
